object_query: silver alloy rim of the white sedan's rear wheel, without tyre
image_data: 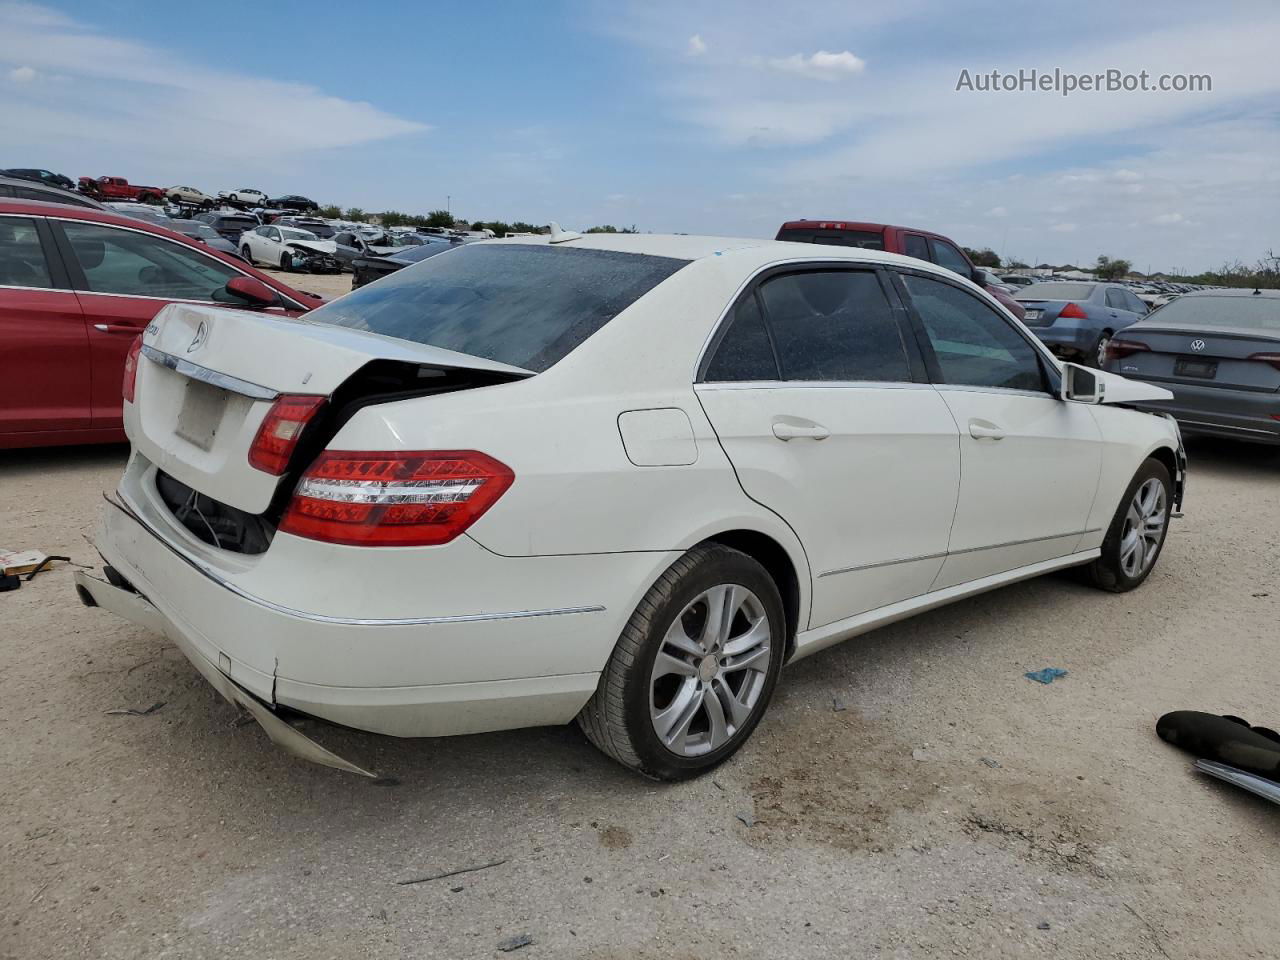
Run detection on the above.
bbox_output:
[649,584,773,756]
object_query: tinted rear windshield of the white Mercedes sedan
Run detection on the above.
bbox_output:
[306,243,689,372]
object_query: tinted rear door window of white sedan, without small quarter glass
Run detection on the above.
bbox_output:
[760,270,911,381]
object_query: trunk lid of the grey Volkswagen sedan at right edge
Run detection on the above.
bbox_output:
[1115,324,1280,393]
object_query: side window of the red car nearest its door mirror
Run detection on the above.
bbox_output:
[61,221,239,300]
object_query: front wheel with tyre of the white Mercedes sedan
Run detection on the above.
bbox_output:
[1085,457,1172,594]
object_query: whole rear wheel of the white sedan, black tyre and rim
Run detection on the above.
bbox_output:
[577,544,787,780]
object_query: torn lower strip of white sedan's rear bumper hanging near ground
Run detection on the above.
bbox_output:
[74,570,378,777]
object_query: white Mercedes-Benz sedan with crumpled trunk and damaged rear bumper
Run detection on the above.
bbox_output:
[77,229,1185,780]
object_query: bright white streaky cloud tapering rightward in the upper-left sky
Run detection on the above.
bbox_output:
[0,4,429,172]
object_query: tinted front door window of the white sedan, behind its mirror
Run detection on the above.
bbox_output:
[902,274,1044,392]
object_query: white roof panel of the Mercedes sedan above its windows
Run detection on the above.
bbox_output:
[479,233,977,276]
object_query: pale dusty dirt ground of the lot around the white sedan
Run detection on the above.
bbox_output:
[0,440,1280,960]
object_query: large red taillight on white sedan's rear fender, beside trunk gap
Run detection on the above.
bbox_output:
[279,451,516,547]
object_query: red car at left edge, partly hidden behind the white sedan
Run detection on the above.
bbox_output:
[0,200,324,448]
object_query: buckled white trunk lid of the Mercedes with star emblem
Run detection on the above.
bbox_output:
[125,303,531,515]
